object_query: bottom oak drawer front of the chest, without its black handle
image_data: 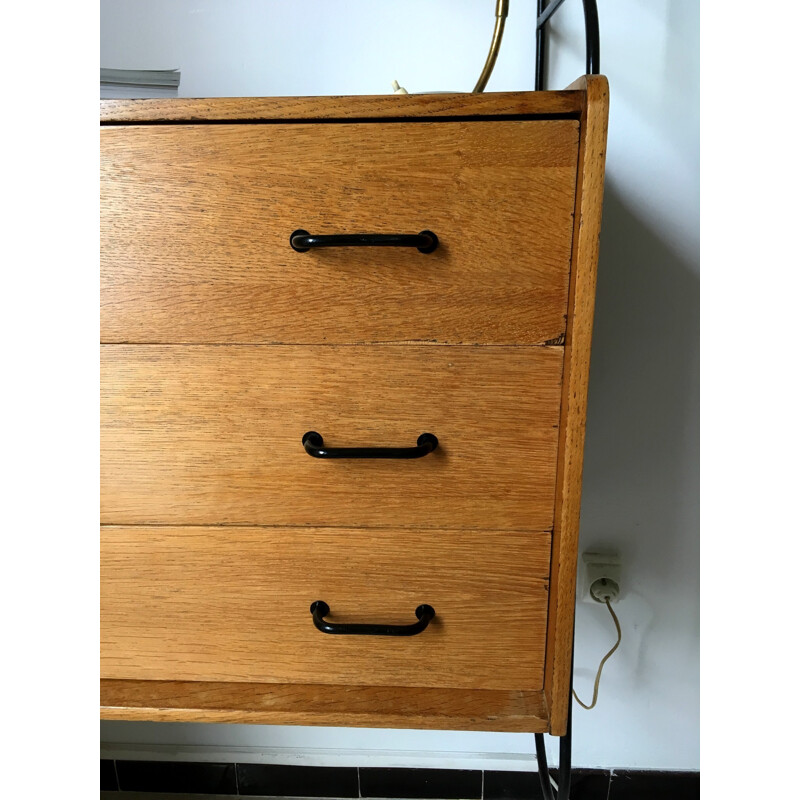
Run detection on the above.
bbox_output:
[101,527,550,689]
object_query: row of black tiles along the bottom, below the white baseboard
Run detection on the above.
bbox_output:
[100,760,700,800]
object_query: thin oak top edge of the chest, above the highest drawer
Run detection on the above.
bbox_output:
[100,90,584,123]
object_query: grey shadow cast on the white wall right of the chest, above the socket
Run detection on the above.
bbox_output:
[576,181,700,675]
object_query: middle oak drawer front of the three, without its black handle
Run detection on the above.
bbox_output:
[101,345,563,530]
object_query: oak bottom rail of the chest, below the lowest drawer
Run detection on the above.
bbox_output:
[100,680,547,733]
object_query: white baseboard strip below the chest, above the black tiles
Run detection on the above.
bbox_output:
[100,742,536,772]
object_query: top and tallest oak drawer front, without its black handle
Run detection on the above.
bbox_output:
[101,120,579,344]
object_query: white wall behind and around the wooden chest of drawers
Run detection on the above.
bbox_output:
[101,0,699,769]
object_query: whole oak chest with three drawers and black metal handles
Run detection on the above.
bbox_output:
[100,76,608,734]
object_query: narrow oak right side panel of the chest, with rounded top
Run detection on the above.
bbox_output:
[545,75,608,736]
